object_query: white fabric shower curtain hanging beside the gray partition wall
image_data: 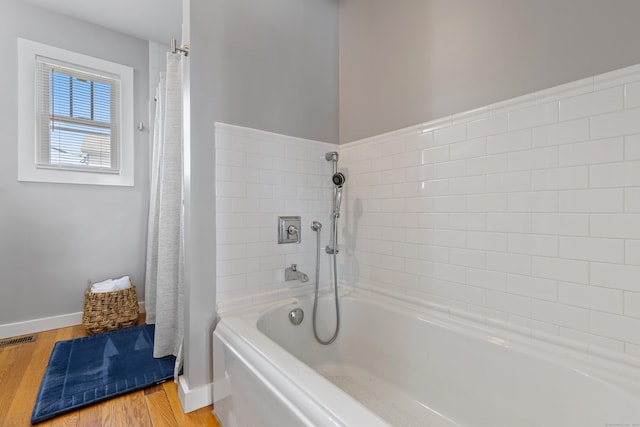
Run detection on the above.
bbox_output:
[145,53,184,376]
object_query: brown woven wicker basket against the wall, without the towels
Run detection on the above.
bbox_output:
[82,280,139,334]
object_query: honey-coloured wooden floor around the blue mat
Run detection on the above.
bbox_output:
[0,320,220,427]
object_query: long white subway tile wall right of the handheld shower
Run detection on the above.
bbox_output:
[342,66,640,355]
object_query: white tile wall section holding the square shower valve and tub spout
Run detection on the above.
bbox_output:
[215,123,336,312]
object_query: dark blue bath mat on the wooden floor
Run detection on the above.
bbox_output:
[31,325,176,424]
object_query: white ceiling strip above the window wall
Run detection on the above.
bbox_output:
[26,0,182,45]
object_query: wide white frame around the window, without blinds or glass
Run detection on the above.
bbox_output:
[18,38,134,187]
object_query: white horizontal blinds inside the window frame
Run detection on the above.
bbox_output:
[36,56,120,173]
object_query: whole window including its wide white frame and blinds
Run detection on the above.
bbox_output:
[18,39,133,186]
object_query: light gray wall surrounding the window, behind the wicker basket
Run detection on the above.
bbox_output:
[0,0,149,325]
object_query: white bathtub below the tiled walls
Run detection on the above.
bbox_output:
[213,291,640,427]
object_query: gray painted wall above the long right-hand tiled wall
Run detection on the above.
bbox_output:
[340,0,640,143]
